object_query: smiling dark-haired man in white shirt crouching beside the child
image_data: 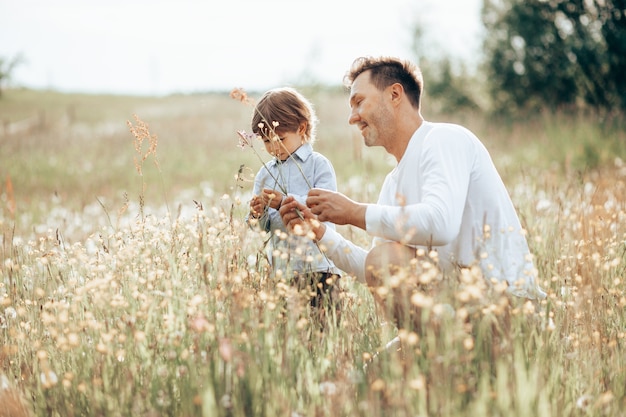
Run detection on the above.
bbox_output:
[280,57,545,324]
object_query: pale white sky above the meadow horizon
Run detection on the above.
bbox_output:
[0,0,481,94]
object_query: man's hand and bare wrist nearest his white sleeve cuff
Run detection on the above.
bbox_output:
[306,188,367,230]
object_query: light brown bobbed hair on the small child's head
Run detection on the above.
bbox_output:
[251,87,318,143]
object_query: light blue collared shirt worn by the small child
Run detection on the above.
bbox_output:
[246,142,339,274]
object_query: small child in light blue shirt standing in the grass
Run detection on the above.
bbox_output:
[247,87,340,319]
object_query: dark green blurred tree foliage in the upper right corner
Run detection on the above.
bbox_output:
[482,0,626,112]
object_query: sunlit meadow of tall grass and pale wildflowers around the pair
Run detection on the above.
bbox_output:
[0,88,626,417]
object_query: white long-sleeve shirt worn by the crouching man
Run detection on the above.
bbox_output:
[320,122,545,298]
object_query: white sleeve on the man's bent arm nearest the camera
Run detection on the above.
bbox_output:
[365,127,473,246]
